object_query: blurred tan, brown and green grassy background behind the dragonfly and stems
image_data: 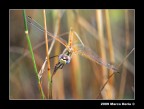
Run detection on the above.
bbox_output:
[9,9,135,99]
